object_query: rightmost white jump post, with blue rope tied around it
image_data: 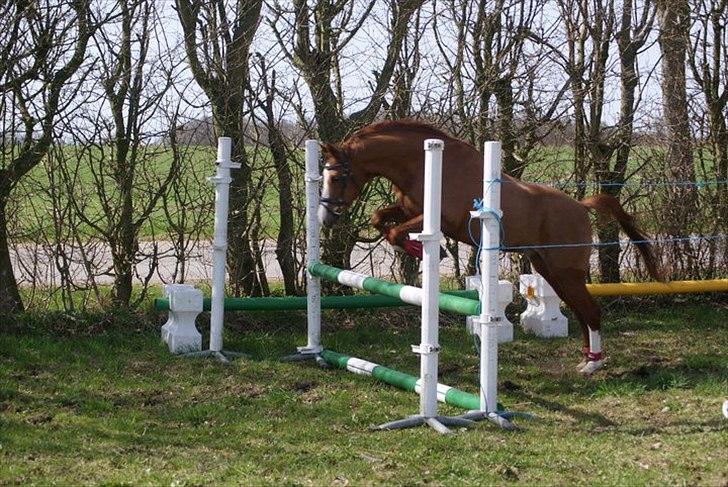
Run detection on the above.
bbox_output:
[463,142,513,429]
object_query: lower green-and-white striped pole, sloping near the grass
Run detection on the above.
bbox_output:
[321,350,480,410]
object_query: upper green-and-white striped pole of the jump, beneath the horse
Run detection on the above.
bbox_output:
[308,262,480,316]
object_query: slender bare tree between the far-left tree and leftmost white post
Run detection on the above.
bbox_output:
[62,0,178,306]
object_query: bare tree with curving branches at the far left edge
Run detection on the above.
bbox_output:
[0,0,94,312]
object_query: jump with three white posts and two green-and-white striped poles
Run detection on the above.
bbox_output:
[291,139,512,433]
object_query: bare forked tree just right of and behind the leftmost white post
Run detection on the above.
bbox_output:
[175,0,263,295]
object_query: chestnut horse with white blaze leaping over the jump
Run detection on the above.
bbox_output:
[318,120,659,374]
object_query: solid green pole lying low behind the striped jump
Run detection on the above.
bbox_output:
[154,291,478,311]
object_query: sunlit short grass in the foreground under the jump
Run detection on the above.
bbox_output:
[0,299,728,485]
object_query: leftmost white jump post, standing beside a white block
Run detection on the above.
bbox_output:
[187,137,243,362]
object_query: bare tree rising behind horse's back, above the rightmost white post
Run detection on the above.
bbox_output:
[433,0,543,177]
